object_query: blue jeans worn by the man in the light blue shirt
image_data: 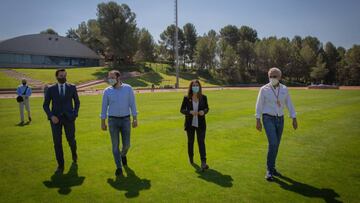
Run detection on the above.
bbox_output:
[108,117,131,168]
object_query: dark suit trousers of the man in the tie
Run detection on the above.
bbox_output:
[50,116,77,168]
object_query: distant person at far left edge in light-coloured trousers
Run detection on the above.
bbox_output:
[16,78,31,125]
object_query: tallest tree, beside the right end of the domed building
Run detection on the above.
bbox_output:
[97,1,138,65]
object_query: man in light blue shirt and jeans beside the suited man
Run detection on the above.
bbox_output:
[100,70,137,176]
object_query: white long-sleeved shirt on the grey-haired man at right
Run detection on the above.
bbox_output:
[255,83,296,118]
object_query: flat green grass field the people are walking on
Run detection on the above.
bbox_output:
[0,90,360,202]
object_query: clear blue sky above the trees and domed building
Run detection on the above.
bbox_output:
[0,0,360,48]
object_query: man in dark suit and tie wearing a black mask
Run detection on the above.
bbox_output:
[43,69,80,173]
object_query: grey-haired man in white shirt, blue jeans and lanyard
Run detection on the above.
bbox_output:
[255,68,297,181]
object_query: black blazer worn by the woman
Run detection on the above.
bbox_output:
[180,95,209,130]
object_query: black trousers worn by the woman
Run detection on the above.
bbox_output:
[186,126,206,161]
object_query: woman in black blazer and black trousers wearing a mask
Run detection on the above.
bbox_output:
[180,80,209,170]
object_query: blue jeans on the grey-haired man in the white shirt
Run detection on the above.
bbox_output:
[262,114,284,173]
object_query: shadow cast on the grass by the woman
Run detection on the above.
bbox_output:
[192,164,233,187]
